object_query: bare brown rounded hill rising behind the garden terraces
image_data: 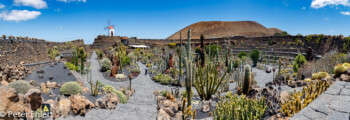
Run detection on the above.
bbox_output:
[167,21,282,39]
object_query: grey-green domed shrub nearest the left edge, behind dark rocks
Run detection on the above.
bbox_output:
[8,80,33,94]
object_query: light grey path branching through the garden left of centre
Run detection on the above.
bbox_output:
[60,53,175,120]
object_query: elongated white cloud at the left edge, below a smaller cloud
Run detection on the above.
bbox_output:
[0,10,41,22]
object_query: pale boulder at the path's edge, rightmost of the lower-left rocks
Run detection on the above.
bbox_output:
[95,93,119,109]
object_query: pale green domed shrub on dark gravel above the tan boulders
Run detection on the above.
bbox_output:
[60,81,83,95]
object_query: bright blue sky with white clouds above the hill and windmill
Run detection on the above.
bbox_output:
[0,0,350,44]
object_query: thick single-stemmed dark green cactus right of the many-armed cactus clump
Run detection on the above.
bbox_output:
[242,65,252,95]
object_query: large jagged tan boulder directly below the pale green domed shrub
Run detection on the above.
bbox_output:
[69,94,95,115]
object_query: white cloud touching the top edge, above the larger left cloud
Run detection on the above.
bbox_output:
[13,0,47,9]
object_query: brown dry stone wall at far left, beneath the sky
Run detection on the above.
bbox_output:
[0,39,84,66]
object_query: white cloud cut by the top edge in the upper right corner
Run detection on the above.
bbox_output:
[311,0,350,9]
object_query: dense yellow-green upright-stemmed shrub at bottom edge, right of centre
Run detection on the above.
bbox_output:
[213,94,267,120]
